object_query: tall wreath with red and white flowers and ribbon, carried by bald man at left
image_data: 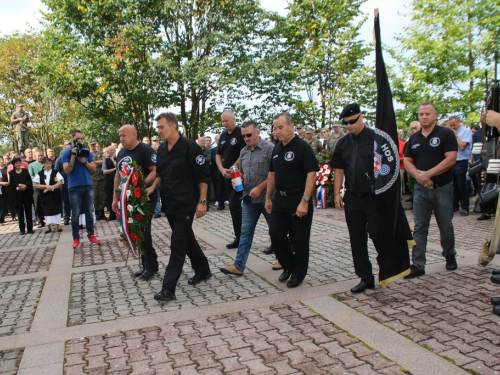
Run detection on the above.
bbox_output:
[115,161,151,255]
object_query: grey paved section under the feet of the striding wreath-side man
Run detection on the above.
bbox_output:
[67,254,280,328]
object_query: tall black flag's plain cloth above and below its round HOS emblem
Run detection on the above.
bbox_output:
[374,10,414,287]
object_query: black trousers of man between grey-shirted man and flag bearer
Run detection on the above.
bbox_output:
[269,194,313,280]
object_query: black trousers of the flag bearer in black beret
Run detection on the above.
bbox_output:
[344,191,378,282]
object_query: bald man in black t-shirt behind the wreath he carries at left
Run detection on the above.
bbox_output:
[113,125,158,280]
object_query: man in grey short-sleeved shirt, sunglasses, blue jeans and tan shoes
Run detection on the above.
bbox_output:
[220,121,274,276]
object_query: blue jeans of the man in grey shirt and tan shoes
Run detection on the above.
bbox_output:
[233,195,269,272]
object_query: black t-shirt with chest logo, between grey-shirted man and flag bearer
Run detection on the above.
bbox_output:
[269,136,319,191]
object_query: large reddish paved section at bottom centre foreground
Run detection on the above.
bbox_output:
[65,305,410,374]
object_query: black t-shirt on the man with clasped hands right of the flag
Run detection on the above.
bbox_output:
[404,125,458,186]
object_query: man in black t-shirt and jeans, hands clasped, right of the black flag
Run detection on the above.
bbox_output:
[404,102,458,279]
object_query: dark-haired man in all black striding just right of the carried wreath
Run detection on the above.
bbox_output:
[148,113,212,301]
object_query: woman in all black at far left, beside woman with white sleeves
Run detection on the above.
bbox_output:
[9,157,33,235]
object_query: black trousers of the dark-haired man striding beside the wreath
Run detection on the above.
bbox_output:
[163,212,210,294]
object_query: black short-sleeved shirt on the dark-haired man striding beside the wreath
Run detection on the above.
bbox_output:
[156,136,210,214]
